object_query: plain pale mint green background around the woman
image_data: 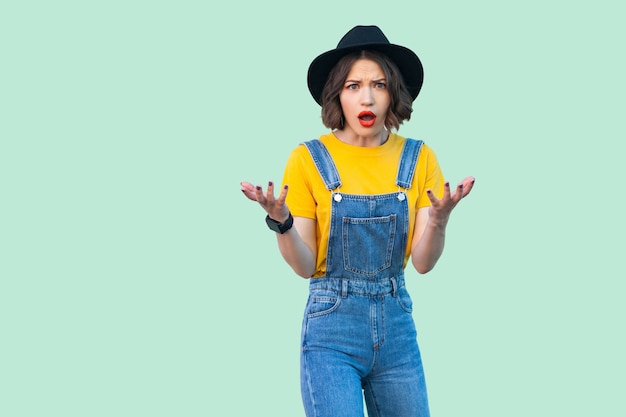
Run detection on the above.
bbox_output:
[0,0,626,417]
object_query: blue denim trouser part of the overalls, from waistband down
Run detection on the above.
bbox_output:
[301,275,429,417]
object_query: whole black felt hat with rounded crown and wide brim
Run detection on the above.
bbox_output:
[307,26,424,105]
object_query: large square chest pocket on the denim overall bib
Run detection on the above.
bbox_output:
[342,214,396,277]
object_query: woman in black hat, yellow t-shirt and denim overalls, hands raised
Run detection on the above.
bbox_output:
[241,26,474,417]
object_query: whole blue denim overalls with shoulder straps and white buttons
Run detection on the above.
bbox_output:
[301,139,429,417]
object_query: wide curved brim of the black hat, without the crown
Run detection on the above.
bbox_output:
[307,44,424,106]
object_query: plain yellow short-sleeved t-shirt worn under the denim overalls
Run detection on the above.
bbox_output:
[283,133,444,277]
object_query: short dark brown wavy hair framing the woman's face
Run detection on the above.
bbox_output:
[322,50,413,130]
